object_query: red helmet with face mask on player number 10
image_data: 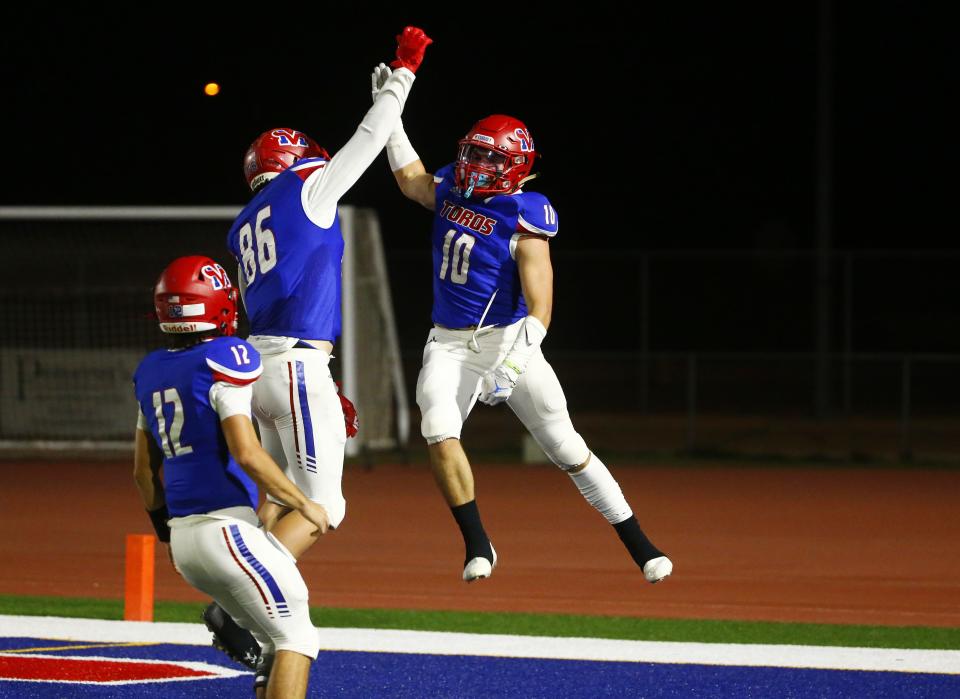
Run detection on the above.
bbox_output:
[454,114,537,197]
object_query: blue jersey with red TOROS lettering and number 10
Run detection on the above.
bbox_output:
[432,164,557,328]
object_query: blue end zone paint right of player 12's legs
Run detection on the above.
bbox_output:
[311,653,960,699]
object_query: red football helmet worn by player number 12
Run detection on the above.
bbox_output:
[153,255,237,335]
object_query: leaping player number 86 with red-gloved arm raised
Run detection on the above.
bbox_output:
[204,27,432,660]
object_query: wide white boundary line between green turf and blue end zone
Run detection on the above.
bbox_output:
[0,615,960,675]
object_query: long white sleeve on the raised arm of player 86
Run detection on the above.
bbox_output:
[302,68,414,228]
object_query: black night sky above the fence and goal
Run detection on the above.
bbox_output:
[0,2,957,249]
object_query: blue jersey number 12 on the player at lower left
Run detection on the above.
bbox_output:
[133,337,263,517]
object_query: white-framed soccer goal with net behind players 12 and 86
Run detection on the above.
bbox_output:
[0,206,409,455]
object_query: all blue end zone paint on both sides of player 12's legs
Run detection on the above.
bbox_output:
[0,638,960,699]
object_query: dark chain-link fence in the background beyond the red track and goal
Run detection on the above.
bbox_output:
[0,216,960,461]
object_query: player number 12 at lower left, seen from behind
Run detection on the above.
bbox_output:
[134,256,329,699]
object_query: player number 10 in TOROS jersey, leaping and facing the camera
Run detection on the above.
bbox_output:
[372,64,673,583]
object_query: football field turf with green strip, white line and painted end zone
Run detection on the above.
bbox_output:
[0,596,960,699]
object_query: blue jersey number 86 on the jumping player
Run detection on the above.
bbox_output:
[227,158,343,342]
